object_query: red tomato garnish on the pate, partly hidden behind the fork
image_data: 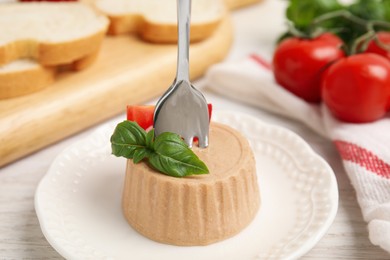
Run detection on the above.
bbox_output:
[127,104,213,130]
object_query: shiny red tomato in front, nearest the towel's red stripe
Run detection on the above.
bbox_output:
[322,53,390,123]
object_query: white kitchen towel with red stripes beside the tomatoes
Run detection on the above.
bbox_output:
[206,55,390,252]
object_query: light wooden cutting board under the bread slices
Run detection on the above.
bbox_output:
[0,17,233,167]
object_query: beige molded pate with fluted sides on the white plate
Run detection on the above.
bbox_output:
[122,123,260,246]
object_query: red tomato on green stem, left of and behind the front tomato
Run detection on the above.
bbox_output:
[273,33,345,102]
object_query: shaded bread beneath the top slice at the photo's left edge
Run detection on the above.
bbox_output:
[0,52,98,100]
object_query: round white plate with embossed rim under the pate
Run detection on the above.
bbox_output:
[35,112,338,260]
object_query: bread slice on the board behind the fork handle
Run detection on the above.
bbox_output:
[95,0,226,43]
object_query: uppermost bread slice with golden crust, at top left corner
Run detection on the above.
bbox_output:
[0,2,109,66]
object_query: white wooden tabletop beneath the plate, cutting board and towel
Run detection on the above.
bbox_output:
[0,0,390,260]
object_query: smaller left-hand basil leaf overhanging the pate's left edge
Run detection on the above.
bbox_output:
[110,120,146,159]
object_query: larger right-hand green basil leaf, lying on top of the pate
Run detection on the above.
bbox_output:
[149,132,209,177]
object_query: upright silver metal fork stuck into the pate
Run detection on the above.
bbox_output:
[154,0,209,148]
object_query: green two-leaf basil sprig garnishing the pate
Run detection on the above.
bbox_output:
[111,120,209,177]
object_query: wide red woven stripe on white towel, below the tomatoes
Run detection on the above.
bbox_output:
[334,140,390,179]
